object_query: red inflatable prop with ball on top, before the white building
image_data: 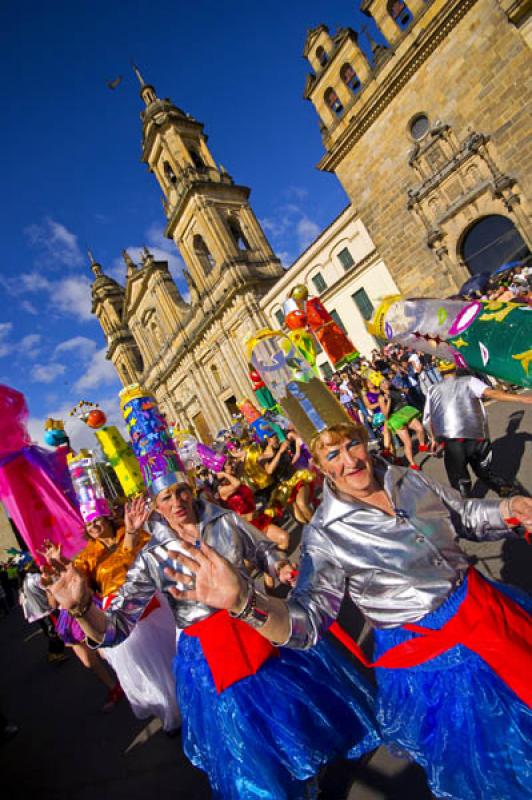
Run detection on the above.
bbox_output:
[288,284,360,368]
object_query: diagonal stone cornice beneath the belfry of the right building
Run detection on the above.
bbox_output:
[318,0,477,172]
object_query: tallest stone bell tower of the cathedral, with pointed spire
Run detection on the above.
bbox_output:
[136,69,283,308]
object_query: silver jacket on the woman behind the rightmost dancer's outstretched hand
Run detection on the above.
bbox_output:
[98,500,286,647]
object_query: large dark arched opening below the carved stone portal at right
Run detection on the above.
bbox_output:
[460,214,530,275]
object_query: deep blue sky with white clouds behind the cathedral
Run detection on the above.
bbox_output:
[0,0,382,446]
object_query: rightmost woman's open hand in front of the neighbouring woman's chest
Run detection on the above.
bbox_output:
[164,542,246,610]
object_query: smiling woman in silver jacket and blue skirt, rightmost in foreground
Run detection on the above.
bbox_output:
[179,418,532,800]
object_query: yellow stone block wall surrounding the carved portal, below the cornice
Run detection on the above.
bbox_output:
[322,0,532,295]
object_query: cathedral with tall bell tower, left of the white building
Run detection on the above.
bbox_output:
[91,74,283,442]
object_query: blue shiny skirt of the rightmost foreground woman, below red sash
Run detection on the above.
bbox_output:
[375,581,532,800]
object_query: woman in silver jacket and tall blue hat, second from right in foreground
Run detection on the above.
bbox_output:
[45,473,380,800]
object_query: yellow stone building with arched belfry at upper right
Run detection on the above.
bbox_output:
[304,0,532,296]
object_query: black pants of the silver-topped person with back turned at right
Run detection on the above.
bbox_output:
[443,439,512,497]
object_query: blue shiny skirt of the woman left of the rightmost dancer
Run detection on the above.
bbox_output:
[175,634,380,800]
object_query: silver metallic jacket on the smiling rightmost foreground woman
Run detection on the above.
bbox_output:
[283,467,513,648]
